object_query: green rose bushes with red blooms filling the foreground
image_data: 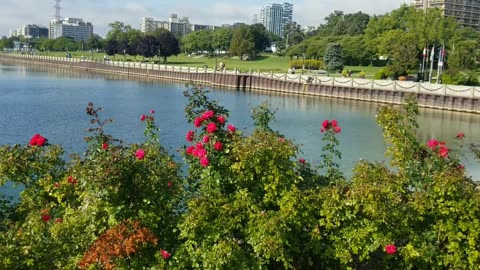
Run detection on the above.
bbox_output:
[0,84,480,269]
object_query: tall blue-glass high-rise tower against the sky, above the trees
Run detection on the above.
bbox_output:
[260,3,293,37]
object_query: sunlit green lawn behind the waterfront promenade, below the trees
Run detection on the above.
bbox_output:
[38,51,381,78]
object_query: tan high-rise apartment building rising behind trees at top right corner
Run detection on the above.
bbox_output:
[413,0,480,30]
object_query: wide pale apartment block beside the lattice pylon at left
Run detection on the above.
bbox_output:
[48,18,93,42]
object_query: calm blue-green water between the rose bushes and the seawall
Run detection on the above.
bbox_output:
[0,64,480,198]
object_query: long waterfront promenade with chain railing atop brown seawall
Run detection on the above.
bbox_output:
[0,54,480,114]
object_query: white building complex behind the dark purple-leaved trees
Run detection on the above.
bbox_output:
[140,14,215,37]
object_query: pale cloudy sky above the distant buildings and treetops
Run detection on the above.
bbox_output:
[0,0,412,37]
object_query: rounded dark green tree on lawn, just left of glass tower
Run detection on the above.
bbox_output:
[230,25,255,60]
